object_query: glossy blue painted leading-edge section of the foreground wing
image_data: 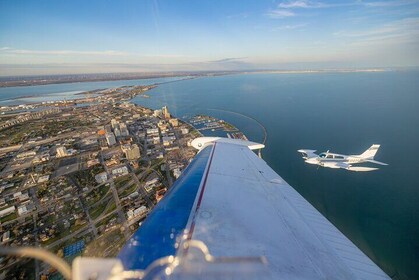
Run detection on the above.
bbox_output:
[118,146,212,270]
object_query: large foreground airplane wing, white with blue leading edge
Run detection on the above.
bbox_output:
[99,141,390,279]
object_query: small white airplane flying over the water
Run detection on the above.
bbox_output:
[298,144,388,171]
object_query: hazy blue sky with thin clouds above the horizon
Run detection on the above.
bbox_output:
[0,0,419,75]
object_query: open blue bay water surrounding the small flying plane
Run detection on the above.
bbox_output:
[134,71,419,279]
